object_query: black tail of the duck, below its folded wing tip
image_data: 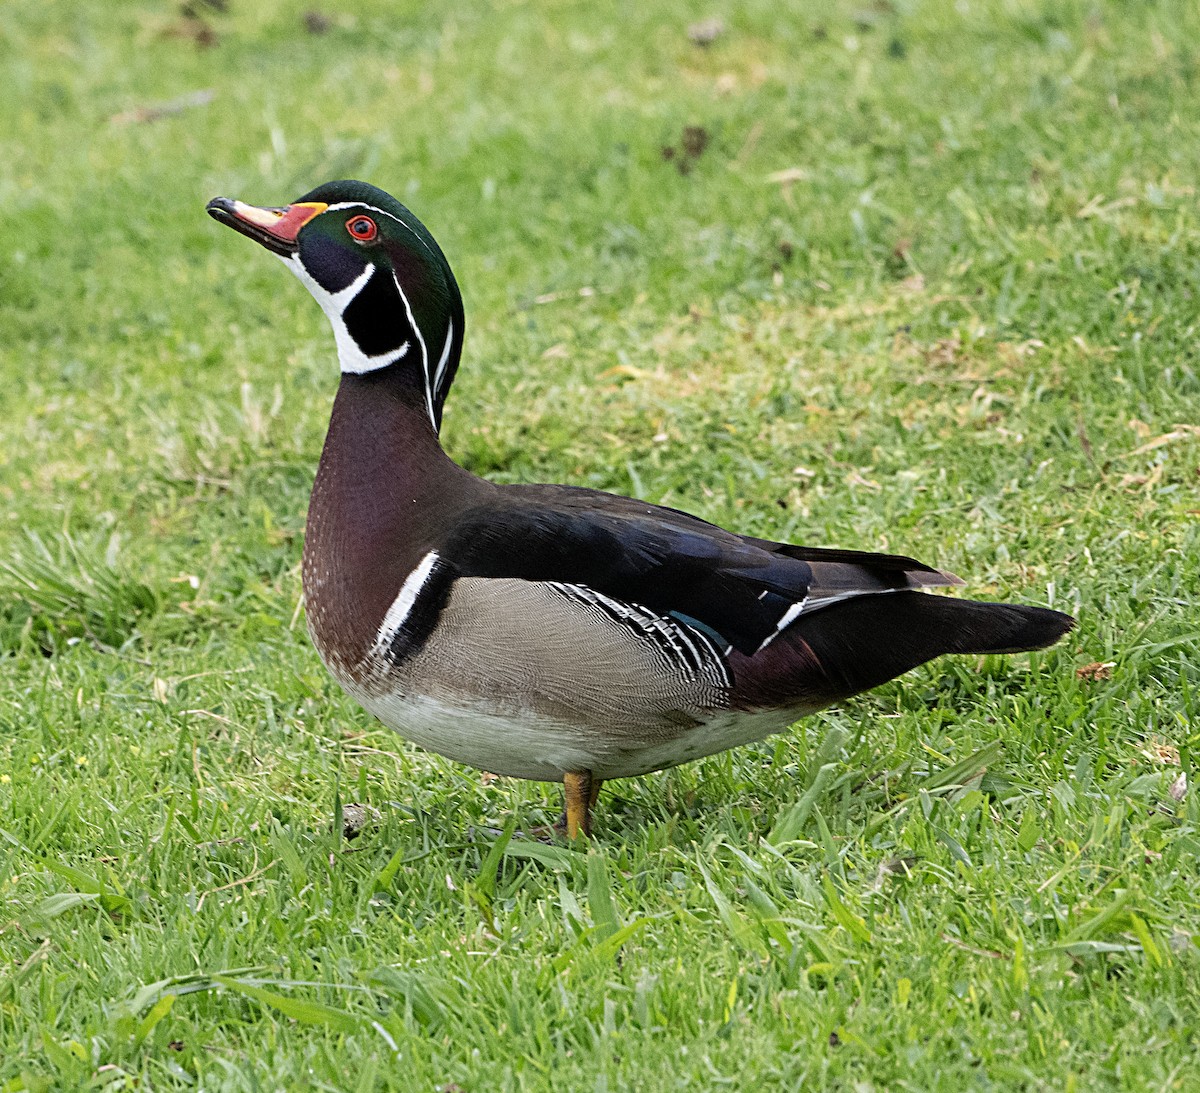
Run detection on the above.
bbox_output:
[777,591,1075,701]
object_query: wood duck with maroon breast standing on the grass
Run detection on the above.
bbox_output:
[208,181,1074,839]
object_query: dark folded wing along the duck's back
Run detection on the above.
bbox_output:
[443,486,961,656]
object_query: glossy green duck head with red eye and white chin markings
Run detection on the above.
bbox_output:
[206,181,463,432]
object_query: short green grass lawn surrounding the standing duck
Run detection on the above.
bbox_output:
[0,0,1200,1091]
